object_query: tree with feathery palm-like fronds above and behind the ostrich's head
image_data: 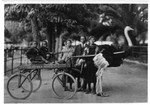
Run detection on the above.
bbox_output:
[96,4,148,45]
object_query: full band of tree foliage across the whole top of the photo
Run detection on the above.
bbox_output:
[5,4,148,44]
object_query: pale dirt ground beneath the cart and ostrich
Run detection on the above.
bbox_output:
[4,63,148,103]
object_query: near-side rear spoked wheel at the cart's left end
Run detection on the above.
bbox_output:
[7,74,33,99]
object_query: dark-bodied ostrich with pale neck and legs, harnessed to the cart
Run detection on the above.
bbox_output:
[93,26,133,96]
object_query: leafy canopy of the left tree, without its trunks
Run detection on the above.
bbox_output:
[5,4,101,33]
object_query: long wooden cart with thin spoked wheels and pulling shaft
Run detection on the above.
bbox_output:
[7,55,97,99]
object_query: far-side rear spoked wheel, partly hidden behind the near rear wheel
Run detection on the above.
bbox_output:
[22,69,42,92]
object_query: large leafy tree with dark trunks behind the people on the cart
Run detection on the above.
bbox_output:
[5,4,101,51]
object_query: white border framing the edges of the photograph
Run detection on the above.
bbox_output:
[0,0,150,105]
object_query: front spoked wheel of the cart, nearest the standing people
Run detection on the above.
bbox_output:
[52,73,77,99]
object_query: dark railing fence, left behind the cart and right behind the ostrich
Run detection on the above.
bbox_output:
[4,46,148,75]
